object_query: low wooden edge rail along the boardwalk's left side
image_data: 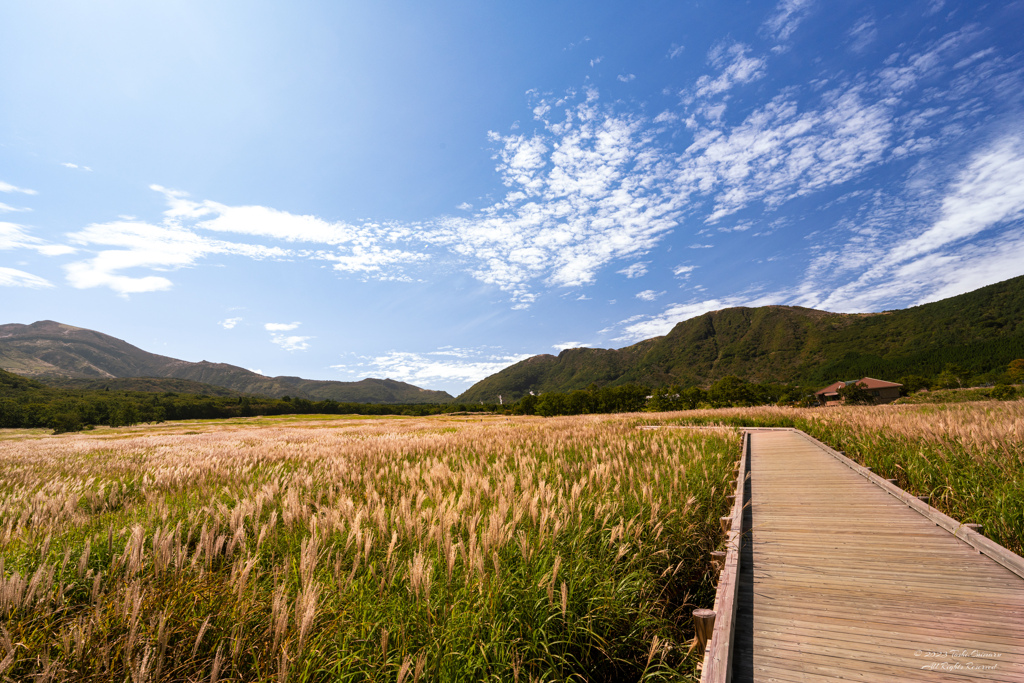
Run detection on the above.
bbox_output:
[700,432,751,683]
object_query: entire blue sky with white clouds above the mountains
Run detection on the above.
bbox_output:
[0,0,1024,394]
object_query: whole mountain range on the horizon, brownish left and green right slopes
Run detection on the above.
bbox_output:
[0,276,1024,403]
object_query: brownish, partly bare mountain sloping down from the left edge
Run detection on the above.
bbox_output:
[0,321,452,403]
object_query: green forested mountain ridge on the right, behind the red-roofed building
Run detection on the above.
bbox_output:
[458,276,1024,402]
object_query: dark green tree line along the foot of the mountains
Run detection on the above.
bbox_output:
[0,358,1024,433]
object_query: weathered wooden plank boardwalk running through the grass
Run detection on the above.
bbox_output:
[731,430,1024,683]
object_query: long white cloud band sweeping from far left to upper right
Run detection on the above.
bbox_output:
[44,28,1017,309]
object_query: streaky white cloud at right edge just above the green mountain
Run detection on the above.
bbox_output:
[796,134,1024,311]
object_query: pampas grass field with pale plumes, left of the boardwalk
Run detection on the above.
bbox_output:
[0,416,739,683]
